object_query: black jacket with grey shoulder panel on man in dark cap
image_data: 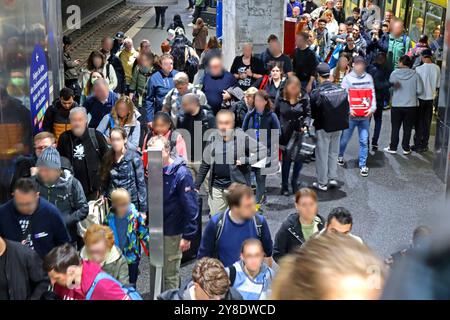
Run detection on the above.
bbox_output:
[317,84,350,132]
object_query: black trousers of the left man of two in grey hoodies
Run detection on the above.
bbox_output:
[390,107,418,151]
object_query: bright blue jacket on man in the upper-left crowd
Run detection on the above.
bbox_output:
[143,70,178,122]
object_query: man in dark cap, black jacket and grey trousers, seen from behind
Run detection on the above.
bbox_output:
[310,62,350,191]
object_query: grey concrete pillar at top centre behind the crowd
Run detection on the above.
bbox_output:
[223,0,286,67]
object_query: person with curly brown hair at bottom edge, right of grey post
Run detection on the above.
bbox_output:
[158,258,243,300]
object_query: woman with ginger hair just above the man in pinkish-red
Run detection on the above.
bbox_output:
[80,224,129,284]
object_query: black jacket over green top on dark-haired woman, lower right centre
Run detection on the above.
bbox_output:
[273,213,325,262]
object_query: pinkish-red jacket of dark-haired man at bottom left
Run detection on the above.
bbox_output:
[53,261,130,300]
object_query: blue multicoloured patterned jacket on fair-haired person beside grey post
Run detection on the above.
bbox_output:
[106,204,149,264]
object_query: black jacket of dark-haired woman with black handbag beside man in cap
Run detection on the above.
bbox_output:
[275,92,311,146]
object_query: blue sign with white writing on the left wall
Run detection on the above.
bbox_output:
[30,44,50,134]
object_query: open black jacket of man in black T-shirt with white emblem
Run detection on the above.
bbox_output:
[58,129,108,196]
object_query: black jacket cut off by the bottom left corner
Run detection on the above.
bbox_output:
[4,239,50,300]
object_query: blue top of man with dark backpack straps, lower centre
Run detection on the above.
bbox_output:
[197,210,273,267]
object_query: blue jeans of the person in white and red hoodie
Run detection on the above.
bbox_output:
[339,118,370,168]
